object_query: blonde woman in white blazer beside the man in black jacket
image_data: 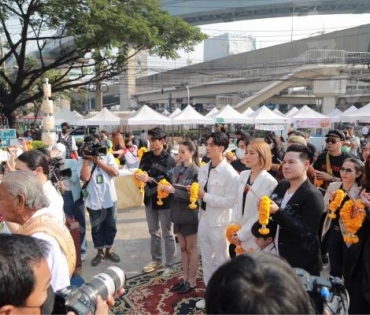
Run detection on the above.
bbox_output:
[232,140,277,250]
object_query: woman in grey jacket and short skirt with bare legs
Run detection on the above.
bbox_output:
[158,140,199,294]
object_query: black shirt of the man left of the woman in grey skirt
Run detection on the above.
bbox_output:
[139,150,175,209]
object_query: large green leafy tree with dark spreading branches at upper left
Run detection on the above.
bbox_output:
[0,0,206,126]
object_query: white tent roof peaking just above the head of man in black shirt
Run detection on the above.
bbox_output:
[123,105,171,126]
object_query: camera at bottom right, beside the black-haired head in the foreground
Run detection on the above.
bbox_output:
[294,268,349,314]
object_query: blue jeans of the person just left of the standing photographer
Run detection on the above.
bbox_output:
[63,190,87,254]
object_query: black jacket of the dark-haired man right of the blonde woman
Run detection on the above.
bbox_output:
[271,180,324,276]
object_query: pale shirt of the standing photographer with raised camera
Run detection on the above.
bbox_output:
[80,153,118,210]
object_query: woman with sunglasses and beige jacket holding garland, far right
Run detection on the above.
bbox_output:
[321,158,363,277]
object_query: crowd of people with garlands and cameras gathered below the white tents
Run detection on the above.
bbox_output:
[0,123,370,314]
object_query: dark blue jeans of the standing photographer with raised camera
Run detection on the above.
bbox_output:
[87,206,117,249]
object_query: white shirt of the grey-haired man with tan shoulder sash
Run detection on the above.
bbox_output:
[31,208,70,292]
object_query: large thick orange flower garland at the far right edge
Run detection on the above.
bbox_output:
[340,199,366,244]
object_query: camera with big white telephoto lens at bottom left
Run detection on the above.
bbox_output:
[53,266,125,314]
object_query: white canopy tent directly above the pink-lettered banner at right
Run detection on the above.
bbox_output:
[289,105,332,128]
